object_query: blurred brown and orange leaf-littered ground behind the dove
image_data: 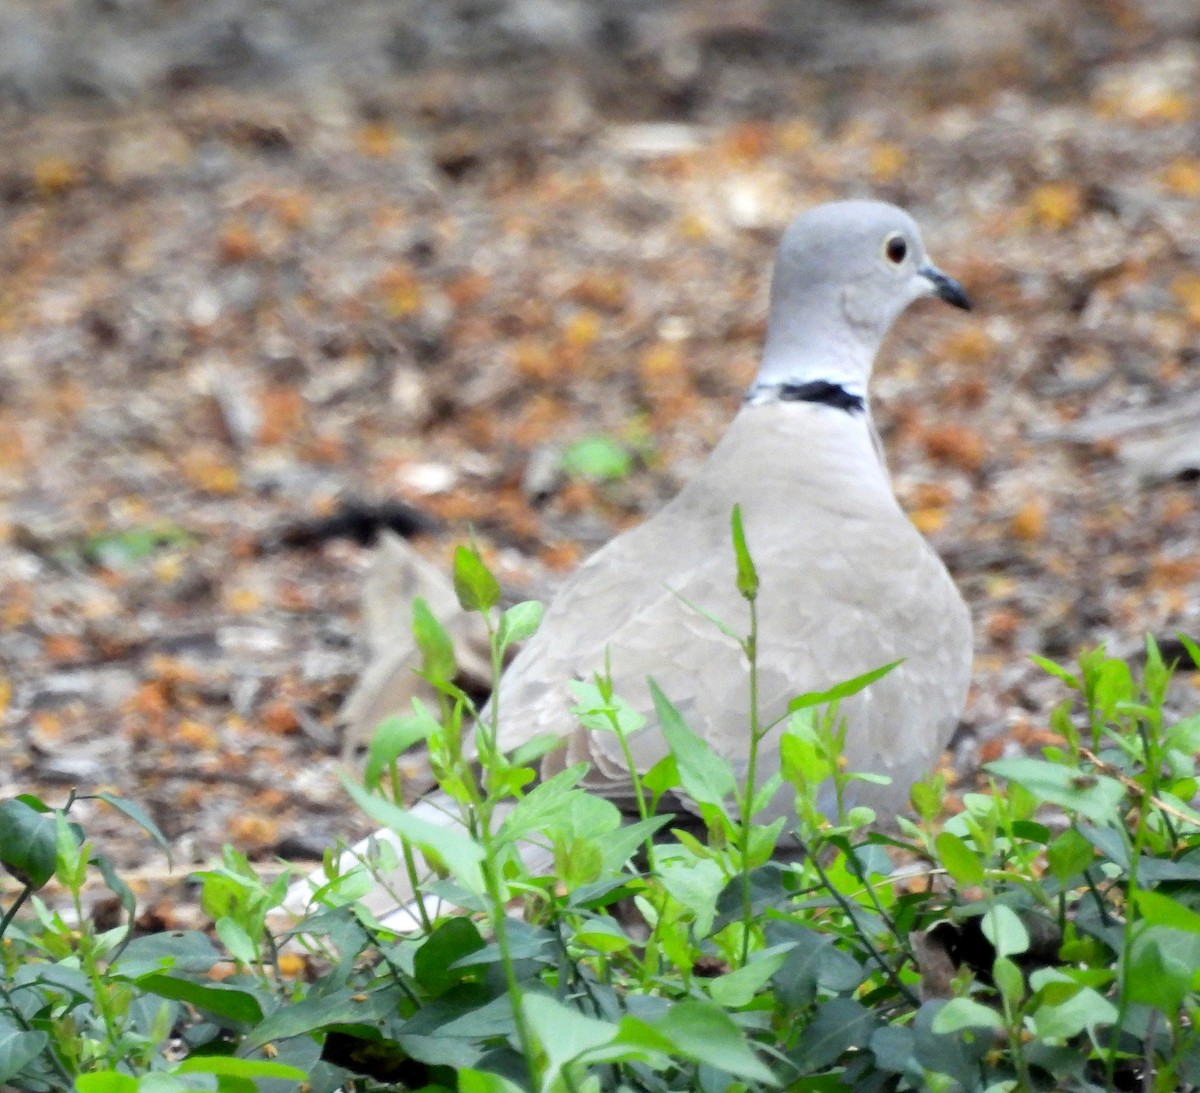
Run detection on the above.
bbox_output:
[0,0,1200,921]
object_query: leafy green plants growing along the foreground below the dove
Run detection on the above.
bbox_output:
[0,527,1200,1093]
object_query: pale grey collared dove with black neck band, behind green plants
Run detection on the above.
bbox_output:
[283,200,972,926]
